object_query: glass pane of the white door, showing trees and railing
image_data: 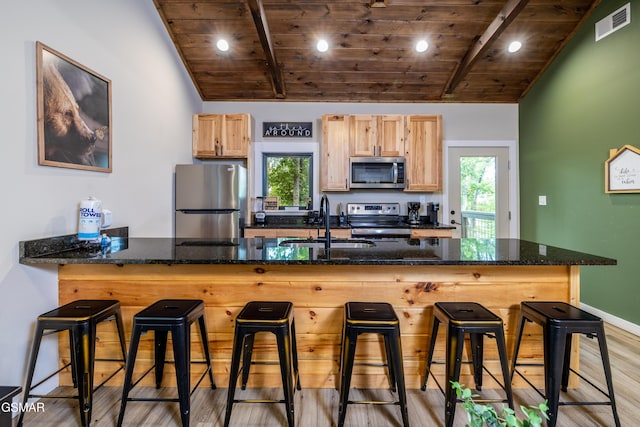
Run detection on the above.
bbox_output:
[460,156,496,238]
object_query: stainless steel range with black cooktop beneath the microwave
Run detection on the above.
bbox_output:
[347,203,411,237]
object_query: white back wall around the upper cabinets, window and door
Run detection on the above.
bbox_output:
[204,102,518,215]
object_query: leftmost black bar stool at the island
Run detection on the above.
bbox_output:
[17,300,126,427]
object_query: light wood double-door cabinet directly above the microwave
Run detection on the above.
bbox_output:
[349,114,405,157]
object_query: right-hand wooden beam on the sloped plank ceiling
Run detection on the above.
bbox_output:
[445,0,529,95]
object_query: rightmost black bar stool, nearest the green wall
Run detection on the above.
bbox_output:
[511,301,620,427]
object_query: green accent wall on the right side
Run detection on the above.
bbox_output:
[519,0,640,325]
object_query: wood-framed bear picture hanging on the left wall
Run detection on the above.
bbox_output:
[36,42,112,172]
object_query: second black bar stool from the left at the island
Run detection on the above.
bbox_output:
[118,299,216,427]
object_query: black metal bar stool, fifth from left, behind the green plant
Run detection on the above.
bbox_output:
[422,302,513,427]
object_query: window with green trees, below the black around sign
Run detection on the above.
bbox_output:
[262,153,313,209]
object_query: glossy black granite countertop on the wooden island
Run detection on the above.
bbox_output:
[20,228,616,266]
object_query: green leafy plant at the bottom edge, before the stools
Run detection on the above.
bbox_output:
[451,381,549,427]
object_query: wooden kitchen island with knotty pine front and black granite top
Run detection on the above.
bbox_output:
[20,232,616,388]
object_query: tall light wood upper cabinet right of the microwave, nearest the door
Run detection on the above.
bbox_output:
[404,115,442,192]
